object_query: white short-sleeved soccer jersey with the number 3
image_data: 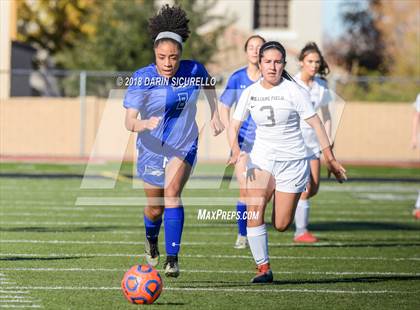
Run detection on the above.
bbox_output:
[233,79,315,161]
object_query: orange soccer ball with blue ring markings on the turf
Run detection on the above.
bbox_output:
[121,265,163,304]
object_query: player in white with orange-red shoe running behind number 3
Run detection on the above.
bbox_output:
[294,42,332,243]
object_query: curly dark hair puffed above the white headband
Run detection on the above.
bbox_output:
[149,4,190,46]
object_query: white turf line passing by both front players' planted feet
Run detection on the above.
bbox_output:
[0,267,420,276]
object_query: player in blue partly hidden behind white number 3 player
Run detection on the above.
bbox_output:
[220,35,265,249]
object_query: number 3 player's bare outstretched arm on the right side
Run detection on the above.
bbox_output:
[305,114,347,183]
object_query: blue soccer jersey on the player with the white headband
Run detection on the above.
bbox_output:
[124,60,209,158]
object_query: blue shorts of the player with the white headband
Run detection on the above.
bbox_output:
[137,146,197,188]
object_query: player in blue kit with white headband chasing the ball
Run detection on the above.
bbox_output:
[124,5,224,277]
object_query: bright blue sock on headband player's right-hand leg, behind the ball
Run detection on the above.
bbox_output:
[164,205,184,256]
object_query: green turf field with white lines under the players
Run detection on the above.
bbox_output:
[0,164,420,309]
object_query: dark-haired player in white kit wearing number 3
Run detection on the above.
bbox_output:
[229,41,346,283]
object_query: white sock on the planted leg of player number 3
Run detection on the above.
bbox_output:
[246,224,269,266]
